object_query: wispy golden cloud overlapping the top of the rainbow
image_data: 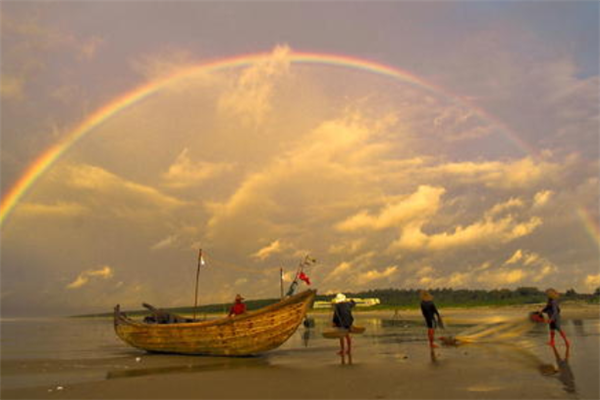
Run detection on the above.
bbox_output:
[218,46,291,127]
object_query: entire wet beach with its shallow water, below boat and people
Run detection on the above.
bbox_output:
[1,306,600,399]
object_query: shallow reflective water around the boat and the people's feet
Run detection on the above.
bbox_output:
[0,313,600,399]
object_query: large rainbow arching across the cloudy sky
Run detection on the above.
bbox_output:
[0,51,592,245]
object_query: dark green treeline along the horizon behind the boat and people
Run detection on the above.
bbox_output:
[76,287,600,318]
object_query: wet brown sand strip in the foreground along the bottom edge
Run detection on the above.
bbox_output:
[2,350,563,399]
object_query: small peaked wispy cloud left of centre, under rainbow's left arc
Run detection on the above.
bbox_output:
[162,148,233,188]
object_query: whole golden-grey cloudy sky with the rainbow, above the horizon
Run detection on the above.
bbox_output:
[0,1,600,316]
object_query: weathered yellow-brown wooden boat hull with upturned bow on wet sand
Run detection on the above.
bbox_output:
[114,290,316,356]
